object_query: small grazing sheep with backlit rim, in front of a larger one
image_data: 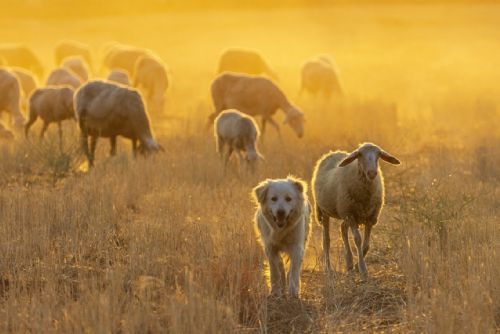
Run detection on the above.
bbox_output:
[214,109,263,170]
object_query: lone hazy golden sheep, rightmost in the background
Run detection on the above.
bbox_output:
[299,55,342,98]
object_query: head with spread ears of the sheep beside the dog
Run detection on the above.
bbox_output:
[339,143,401,181]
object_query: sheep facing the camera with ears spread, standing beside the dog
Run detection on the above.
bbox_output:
[312,143,400,277]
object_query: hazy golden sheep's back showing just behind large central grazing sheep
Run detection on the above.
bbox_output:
[217,49,278,80]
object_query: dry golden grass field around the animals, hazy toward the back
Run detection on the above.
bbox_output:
[0,4,500,333]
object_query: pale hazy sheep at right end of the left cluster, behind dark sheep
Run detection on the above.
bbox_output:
[133,56,168,114]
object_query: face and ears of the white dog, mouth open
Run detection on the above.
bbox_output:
[254,177,306,229]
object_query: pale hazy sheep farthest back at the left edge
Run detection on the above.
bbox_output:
[0,45,43,79]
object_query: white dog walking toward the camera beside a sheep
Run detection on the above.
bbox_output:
[253,176,311,297]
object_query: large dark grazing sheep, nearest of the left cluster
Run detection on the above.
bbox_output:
[74,80,163,166]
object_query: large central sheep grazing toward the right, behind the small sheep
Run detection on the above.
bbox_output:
[209,73,304,138]
